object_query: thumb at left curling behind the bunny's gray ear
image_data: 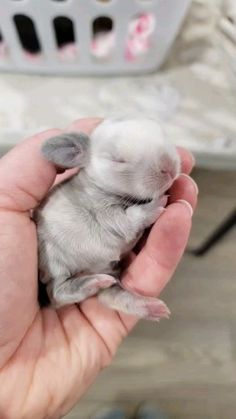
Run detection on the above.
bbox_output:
[0,119,101,211]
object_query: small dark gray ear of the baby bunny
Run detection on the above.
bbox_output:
[42,132,90,169]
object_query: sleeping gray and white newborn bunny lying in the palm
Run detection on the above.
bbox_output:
[35,118,180,320]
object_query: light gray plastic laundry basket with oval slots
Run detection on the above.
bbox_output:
[0,0,191,75]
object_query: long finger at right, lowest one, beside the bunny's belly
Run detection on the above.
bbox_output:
[122,201,192,296]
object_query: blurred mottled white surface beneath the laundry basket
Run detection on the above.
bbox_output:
[0,0,236,168]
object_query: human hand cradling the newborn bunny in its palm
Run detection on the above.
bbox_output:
[0,119,197,419]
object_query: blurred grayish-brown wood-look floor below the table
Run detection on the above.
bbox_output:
[67,170,236,419]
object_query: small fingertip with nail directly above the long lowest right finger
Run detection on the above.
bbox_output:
[168,174,198,209]
